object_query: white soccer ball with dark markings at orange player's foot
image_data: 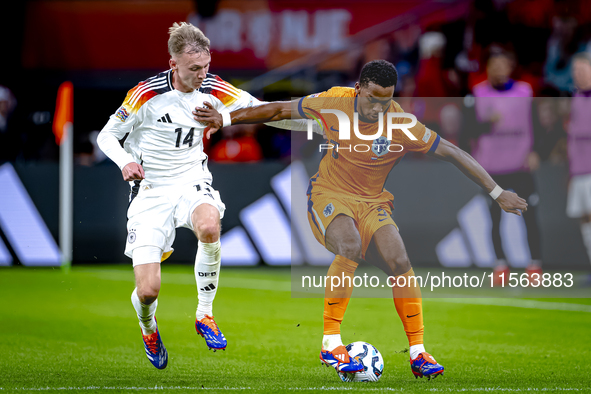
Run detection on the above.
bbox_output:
[338,341,384,382]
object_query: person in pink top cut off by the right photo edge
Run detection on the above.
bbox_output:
[566,53,591,268]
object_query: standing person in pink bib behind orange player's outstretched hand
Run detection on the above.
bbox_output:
[472,47,542,283]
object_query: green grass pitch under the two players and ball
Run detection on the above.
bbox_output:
[0,264,591,393]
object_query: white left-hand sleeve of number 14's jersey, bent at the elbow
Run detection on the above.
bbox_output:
[96,106,136,170]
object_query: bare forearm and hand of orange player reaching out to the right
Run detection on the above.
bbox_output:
[430,138,527,216]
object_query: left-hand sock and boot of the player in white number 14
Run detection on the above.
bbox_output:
[131,288,168,369]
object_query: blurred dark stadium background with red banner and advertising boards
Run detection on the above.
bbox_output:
[0,0,591,269]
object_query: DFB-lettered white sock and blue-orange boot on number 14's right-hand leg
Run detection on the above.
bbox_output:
[195,240,227,351]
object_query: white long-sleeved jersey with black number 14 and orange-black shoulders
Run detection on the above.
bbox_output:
[98,70,286,186]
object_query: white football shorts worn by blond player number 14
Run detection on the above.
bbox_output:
[125,183,226,257]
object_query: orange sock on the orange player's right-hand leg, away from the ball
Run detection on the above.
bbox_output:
[392,268,424,346]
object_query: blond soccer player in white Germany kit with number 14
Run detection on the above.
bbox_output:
[98,22,306,369]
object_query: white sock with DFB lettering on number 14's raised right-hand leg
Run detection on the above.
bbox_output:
[195,240,222,320]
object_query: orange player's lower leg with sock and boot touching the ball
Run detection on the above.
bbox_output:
[320,255,363,372]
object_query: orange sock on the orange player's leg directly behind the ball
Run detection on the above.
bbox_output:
[324,255,358,335]
